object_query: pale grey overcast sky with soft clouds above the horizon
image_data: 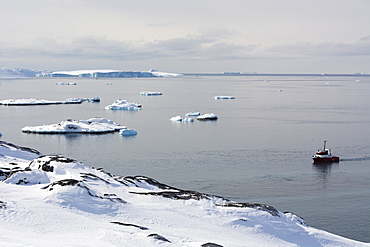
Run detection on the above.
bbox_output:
[0,0,370,73]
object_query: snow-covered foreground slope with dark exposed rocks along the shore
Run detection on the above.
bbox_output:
[0,142,370,247]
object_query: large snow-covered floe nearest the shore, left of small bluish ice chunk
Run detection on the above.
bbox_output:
[22,118,126,134]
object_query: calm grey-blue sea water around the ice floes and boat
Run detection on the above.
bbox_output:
[0,76,370,242]
